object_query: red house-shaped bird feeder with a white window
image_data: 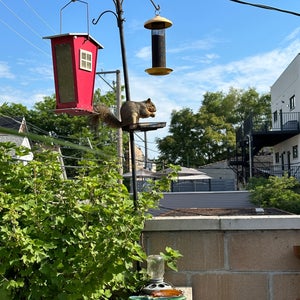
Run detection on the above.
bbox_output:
[45,33,103,115]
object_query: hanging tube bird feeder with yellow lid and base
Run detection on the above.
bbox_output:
[144,15,173,75]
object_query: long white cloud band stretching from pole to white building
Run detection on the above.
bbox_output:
[130,39,300,158]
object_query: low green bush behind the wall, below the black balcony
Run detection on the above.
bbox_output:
[248,174,300,214]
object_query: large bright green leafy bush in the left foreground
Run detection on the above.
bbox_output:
[0,143,178,300]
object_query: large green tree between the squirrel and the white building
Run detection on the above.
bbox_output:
[157,88,271,166]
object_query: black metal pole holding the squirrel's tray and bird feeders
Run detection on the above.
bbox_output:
[114,0,138,209]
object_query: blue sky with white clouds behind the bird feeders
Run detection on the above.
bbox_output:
[0,0,300,158]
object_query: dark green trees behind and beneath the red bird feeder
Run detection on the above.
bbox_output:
[0,89,128,177]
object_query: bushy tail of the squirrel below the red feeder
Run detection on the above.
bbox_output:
[90,104,122,130]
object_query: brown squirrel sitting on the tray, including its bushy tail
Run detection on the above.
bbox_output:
[92,98,156,128]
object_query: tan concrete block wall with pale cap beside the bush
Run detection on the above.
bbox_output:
[143,215,300,300]
